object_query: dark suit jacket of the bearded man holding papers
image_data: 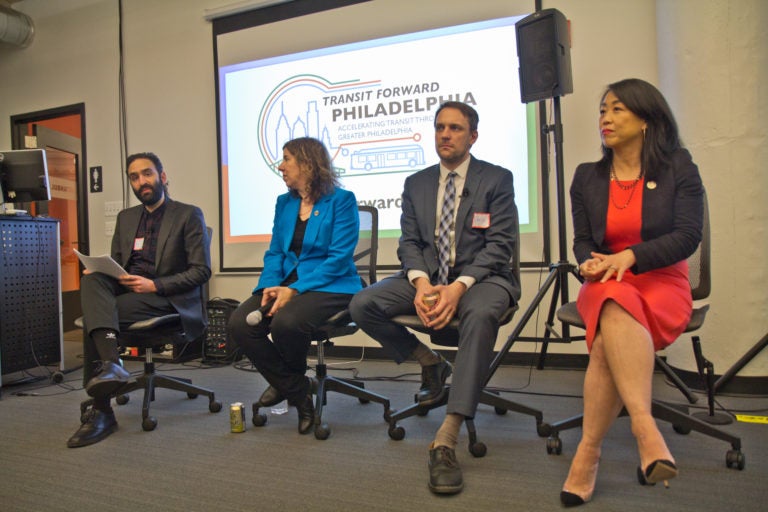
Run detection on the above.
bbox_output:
[112,198,211,340]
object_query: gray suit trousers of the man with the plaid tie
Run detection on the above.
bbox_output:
[349,276,511,418]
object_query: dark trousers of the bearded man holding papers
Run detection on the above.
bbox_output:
[80,272,176,383]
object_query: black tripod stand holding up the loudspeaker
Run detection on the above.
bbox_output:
[489,96,584,375]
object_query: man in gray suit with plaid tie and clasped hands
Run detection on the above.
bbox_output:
[350,102,520,494]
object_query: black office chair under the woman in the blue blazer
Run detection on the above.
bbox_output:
[253,205,392,440]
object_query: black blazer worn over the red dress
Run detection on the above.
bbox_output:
[571,149,704,274]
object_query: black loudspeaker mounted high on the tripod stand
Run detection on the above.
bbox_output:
[515,9,573,103]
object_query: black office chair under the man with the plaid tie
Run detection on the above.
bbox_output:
[388,236,549,457]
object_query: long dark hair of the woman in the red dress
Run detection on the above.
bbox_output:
[600,78,682,178]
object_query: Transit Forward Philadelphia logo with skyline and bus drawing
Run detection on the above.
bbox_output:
[258,75,468,177]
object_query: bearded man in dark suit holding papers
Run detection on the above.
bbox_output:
[67,153,211,448]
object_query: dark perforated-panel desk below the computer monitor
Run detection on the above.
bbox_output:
[0,215,64,384]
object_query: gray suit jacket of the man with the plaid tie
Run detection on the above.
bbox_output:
[397,156,520,302]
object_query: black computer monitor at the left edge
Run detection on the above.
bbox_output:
[0,149,51,208]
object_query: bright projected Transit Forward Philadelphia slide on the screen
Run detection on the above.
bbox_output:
[220,16,528,242]
